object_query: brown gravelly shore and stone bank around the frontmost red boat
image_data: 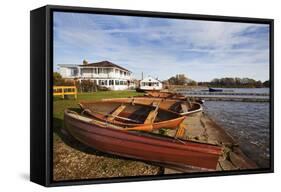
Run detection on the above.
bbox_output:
[53,112,257,181]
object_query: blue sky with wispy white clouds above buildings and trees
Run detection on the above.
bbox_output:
[54,12,269,81]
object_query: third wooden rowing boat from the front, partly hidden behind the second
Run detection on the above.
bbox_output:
[103,97,203,116]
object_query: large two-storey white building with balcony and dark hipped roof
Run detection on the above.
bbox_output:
[58,61,132,90]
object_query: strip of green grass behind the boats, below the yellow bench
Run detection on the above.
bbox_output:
[53,90,143,129]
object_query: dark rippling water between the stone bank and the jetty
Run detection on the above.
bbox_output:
[204,101,270,168]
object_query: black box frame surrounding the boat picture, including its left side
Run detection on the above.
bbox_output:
[30,5,274,186]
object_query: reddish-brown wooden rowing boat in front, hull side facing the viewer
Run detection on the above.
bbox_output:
[64,110,222,171]
